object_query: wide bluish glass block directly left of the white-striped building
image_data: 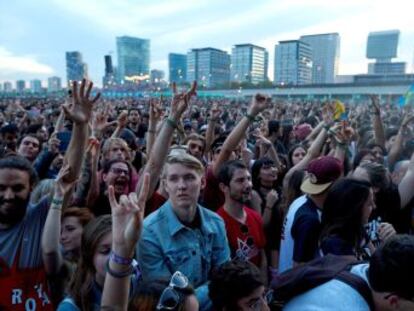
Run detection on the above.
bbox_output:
[187,48,230,88]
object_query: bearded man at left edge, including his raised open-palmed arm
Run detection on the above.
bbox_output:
[0,80,99,311]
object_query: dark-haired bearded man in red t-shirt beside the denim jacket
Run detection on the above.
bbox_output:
[217,160,267,276]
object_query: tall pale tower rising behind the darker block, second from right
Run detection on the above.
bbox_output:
[300,33,340,84]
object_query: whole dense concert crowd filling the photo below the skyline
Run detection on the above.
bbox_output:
[0,80,414,311]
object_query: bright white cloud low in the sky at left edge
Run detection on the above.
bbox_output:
[0,46,54,76]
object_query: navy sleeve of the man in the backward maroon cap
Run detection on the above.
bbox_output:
[291,198,321,262]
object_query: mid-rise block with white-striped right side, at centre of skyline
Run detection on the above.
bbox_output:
[230,44,268,84]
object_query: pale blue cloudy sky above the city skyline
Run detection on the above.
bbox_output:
[0,0,414,85]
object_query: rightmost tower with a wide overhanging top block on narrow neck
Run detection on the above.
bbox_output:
[367,30,407,75]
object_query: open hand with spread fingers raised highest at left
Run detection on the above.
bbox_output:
[62,79,101,124]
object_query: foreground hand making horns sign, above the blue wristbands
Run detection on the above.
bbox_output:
[108,173,149,258]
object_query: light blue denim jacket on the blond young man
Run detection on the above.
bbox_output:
[137,200,230,310]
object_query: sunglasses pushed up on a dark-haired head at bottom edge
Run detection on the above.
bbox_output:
[157,271,188,310]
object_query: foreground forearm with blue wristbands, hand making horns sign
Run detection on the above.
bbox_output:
[101,174,149,310]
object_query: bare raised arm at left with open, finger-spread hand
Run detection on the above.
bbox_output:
[62,79,100,184]
